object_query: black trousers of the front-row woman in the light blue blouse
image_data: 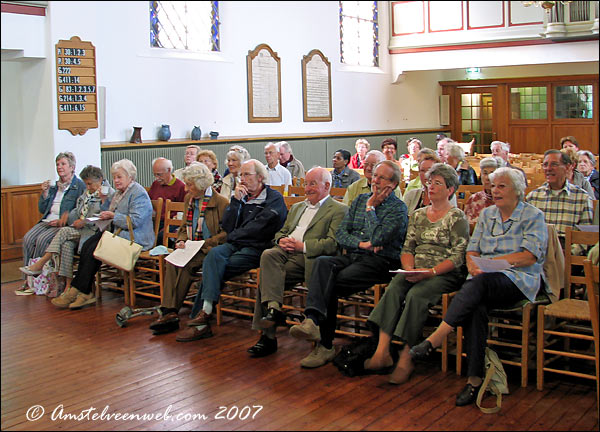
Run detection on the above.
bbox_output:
[444,272,526,378]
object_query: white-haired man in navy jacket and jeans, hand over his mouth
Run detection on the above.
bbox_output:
[176,159,287,342]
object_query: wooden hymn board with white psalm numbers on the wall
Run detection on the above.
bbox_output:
[56,36,98,135]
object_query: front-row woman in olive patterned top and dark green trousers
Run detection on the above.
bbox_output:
[365,163,469,384]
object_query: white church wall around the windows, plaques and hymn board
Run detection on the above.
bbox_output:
[1,1,596,185]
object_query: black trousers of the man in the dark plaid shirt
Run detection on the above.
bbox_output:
[305,254,400,348]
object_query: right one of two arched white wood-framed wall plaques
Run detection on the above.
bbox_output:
[302,49,332,122]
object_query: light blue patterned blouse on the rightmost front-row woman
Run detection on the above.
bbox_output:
[467,202,548,301]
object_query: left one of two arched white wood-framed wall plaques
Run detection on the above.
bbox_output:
[246,44,281,123]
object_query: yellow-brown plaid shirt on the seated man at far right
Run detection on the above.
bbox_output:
[527,180,593,240]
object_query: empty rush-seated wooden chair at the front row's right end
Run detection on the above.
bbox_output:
[537,260,598,390]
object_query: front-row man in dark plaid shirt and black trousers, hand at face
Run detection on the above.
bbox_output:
[290,160,408,368]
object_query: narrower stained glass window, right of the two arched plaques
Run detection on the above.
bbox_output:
[340,1,379,66]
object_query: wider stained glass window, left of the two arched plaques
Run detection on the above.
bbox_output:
[150,1,220,51]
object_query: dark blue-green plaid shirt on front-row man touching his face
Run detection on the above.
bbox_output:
[335,192,408,260]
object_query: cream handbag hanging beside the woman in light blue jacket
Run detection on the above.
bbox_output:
[94,216,142,272]
